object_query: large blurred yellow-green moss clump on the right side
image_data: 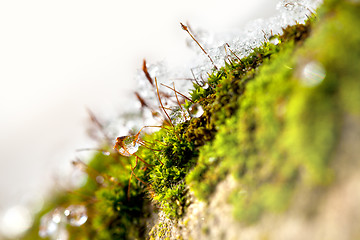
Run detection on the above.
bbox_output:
[187,2,360,223]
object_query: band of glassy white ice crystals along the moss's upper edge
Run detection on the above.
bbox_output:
[104,0,322,136]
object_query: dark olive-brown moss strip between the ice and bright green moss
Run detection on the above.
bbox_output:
[185,42,280,146]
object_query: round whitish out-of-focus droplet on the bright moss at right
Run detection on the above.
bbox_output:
[301,61,326,87]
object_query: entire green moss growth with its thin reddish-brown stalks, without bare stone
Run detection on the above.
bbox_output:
[21,1,360,239]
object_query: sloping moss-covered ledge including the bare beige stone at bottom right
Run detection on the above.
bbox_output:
[23,0,360,239]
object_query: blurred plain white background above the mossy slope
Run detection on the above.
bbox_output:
[0,0,278,238]
